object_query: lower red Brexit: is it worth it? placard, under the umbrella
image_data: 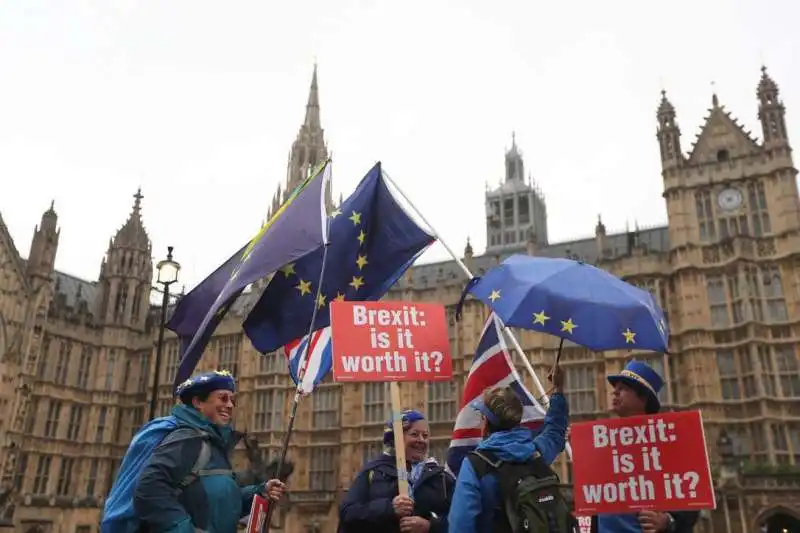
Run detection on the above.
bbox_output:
[570,411,715,515]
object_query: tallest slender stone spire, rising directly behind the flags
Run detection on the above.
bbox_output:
[281,64,332,212]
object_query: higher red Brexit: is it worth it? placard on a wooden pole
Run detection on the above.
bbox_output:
[331,301,453,381]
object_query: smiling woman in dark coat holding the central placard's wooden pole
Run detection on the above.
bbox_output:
[339,410,455,533]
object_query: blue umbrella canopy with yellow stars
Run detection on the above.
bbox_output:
[456,255,669,353]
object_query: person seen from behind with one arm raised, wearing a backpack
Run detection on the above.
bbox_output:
[448,368,569,533]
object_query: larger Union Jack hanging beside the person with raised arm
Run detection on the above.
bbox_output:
[447,313,545,476]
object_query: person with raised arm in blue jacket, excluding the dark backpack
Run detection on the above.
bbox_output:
[448,368,569,533]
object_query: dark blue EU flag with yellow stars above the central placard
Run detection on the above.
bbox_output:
[244,163,435,353]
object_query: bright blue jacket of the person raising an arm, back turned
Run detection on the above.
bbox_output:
[448,394,569,533]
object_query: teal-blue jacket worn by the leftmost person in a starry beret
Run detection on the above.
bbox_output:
[133,405,263,533]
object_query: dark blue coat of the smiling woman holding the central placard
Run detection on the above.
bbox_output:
[339,455,455,533]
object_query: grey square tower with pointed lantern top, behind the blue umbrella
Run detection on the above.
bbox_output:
[486,134,547,253]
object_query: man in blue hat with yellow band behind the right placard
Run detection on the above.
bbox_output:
[592,361,700,533]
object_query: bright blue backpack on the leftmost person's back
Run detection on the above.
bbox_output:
[100,416,211,533]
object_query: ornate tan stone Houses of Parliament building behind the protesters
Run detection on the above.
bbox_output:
[0,65,800,533]
